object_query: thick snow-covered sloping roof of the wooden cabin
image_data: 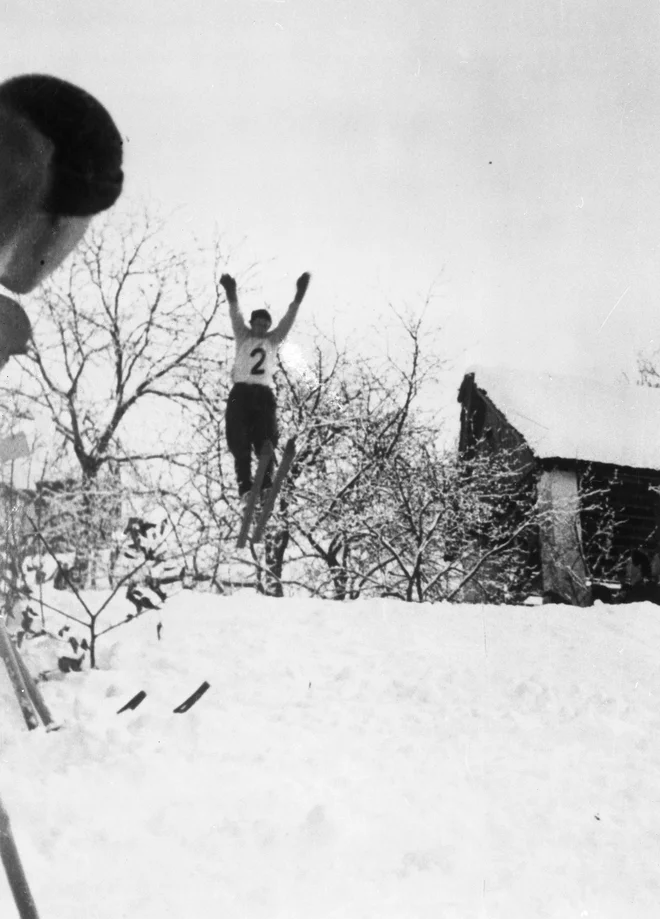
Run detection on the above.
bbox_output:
[468,366,660,470]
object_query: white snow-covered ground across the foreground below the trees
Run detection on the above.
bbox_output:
[0,591,660,919]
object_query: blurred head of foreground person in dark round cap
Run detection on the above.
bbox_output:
[0,74,124,293]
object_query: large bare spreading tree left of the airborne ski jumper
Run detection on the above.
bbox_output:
[3,209,231,584]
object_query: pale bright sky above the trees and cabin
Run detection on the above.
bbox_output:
[0,0,660,386]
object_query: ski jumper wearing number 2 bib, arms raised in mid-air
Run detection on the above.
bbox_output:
[220,272,310,497]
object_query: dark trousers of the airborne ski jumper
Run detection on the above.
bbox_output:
[225,383,279,495]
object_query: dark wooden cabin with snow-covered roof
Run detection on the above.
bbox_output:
[458,367,660,605]
